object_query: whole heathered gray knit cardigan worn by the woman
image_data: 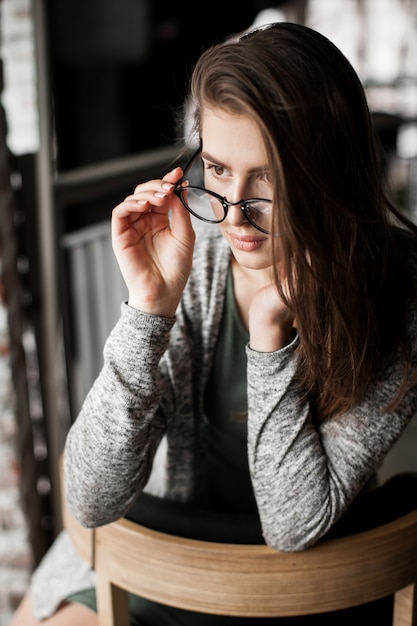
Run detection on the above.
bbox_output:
[32,228,417,619]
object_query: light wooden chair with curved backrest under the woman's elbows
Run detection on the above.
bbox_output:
[63,472,417,626]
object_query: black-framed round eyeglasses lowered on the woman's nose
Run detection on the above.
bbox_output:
[174,148,272,235]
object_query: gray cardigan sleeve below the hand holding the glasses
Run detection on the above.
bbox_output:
[64,304,174,527]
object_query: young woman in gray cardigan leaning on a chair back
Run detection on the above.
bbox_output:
[9,23,417,626]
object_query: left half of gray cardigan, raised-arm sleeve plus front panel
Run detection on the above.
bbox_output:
[64,231,230,527]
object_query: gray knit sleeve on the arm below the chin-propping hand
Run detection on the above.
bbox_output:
[247,326,417,551]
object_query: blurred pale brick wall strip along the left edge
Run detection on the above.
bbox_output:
[0,0,36,626]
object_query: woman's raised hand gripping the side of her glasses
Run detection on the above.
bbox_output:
[112,167,195,317]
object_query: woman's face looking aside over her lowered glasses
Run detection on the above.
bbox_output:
[201,108,274,269]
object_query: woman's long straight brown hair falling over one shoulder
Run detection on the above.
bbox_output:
[190,23,417,419]
